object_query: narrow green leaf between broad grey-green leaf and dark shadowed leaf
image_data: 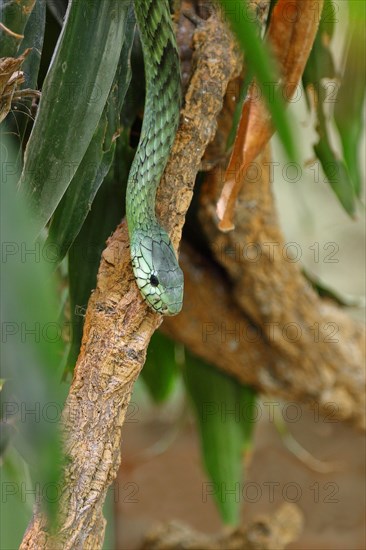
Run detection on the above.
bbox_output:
[46,6,135,262]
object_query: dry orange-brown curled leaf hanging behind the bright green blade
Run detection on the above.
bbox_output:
[217,0,323,231]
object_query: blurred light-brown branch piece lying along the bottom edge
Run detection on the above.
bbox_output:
[141,504,303,550]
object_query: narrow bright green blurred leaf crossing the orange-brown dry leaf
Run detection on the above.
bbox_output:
[221,0,296,159]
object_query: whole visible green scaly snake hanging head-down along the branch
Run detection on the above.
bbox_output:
[126,0,183,315]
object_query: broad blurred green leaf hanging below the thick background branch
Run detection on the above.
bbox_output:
[184,354,255,525]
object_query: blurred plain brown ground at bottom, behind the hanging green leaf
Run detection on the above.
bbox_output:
[115,399,366,550]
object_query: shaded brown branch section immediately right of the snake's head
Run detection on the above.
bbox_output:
[161,242,278,390]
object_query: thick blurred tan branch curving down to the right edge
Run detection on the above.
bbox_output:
[192,148,365,428]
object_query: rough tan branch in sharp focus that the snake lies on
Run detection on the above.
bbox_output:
[21,9,243,550]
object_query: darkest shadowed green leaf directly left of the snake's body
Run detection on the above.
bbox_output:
[66,18,144,372]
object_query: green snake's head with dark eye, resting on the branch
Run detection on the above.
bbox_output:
[131,228,183,315]
